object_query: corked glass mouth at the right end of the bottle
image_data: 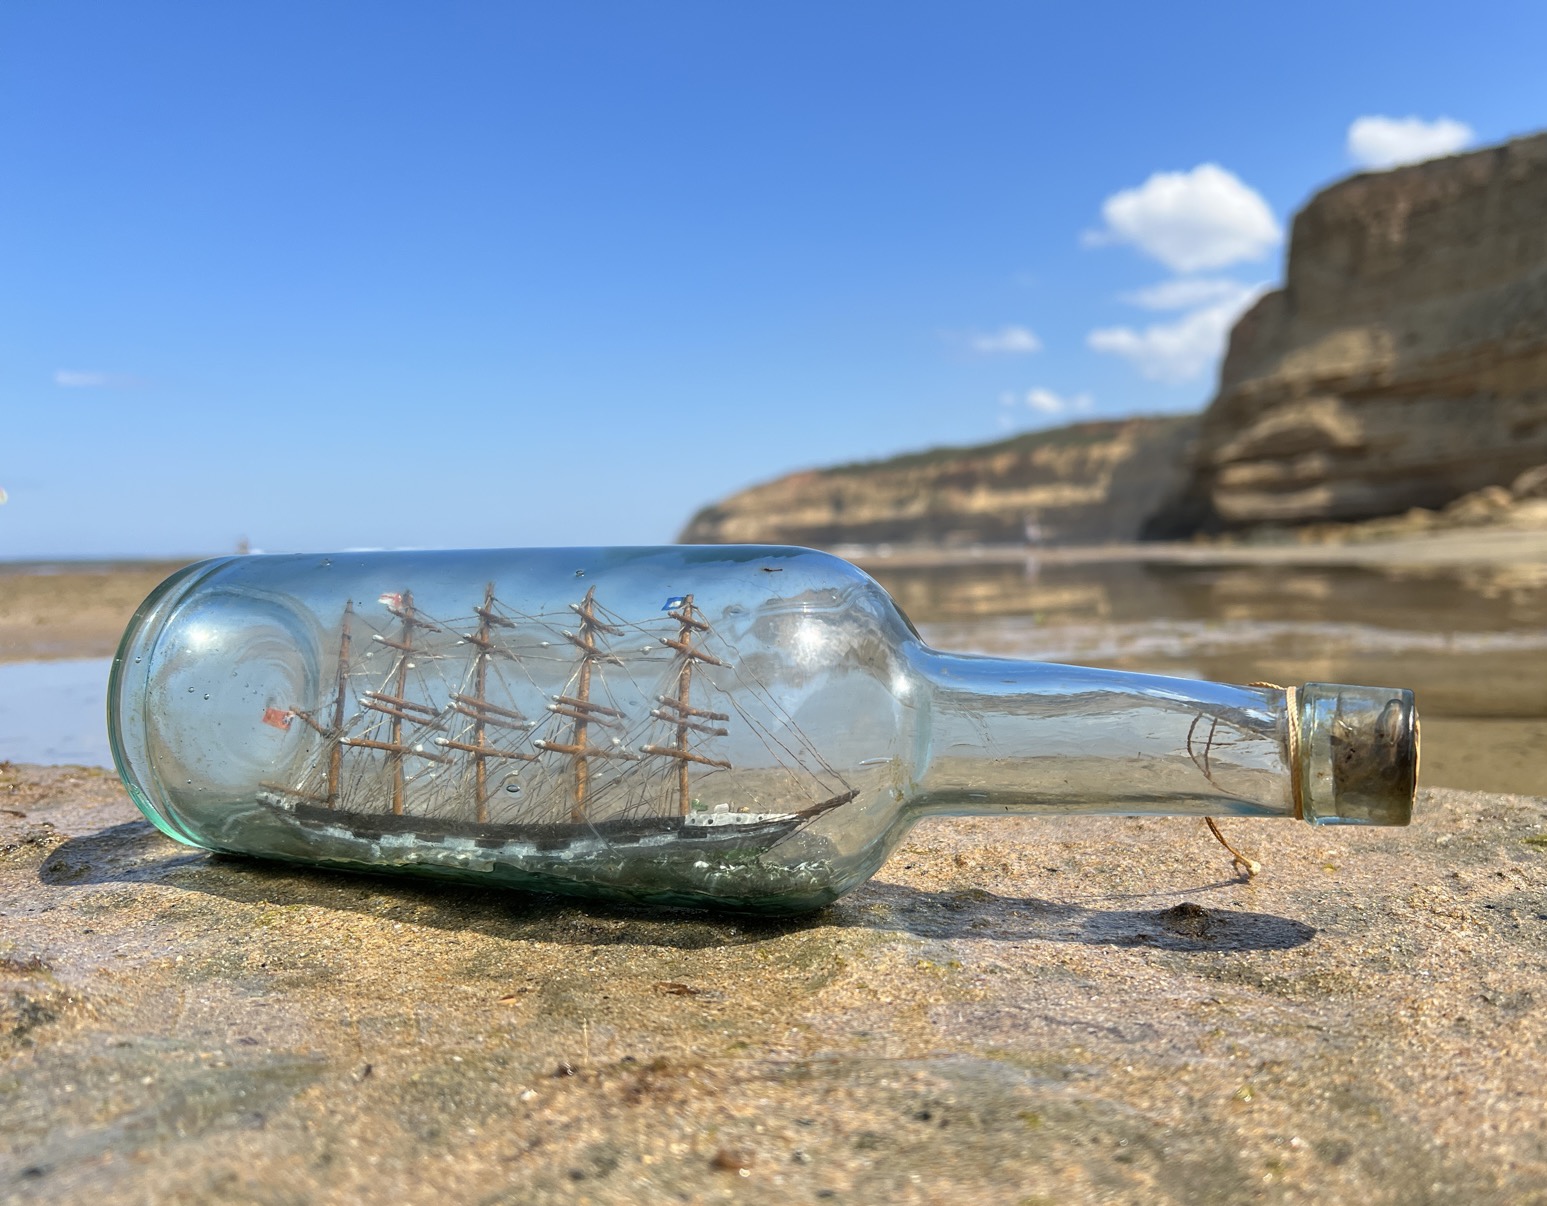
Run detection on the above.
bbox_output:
[1298,682,1419,826]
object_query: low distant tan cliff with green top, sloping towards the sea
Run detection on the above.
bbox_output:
[679,416,1197,546]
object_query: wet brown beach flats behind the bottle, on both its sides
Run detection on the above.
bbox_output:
[0,544,1547,795]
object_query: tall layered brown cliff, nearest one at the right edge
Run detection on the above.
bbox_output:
[1146,135,1547,537]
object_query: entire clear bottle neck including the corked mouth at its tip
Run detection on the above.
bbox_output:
[905,646,1419,826]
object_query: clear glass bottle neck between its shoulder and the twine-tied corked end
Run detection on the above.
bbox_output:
[907,649,1303,816]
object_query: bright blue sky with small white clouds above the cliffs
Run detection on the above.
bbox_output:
[0,0,1547,558]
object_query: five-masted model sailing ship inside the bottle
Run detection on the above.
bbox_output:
[258,583,857,861]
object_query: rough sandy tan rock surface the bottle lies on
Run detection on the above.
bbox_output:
[0,765,1547,1203]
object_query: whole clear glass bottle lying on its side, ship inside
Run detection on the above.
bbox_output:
[108,546,1417,912]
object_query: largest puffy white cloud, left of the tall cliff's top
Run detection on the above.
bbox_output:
[1083,164,1282,272]
